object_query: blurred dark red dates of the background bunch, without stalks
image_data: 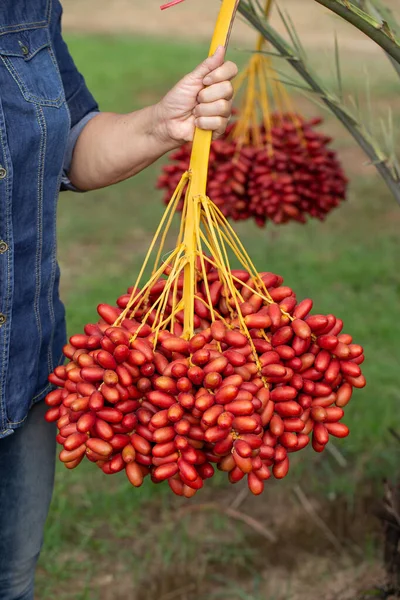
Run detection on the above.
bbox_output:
[157,115,347,227]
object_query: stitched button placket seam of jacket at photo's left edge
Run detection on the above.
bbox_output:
[0,100,13,434]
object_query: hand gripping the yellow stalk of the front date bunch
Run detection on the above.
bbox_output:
[157,46,238,145]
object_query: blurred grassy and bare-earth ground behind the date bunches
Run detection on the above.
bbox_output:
[36,0,400,600]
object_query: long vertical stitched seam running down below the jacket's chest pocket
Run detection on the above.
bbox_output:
[33,106,47,372]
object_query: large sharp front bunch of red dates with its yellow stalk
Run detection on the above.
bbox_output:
[46,0,365,498]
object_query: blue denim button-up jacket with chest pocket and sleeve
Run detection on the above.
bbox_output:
[0,0,98,438]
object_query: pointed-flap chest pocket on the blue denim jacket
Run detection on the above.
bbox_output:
[0,28,65,107]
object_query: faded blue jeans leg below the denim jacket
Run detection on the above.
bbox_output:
[0,402,56,600]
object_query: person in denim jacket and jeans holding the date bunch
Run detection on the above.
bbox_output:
[0,0,237,600]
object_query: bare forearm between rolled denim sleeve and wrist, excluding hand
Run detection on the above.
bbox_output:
[68,105,178,191]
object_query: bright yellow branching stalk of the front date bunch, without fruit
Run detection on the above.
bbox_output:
[116,0,280,352]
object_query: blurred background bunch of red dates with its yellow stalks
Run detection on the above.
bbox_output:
[157,0,347,227]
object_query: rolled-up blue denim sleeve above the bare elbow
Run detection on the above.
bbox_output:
[50,0,99,191]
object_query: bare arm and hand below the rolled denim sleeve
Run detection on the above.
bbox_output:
[68,48,237,190]
